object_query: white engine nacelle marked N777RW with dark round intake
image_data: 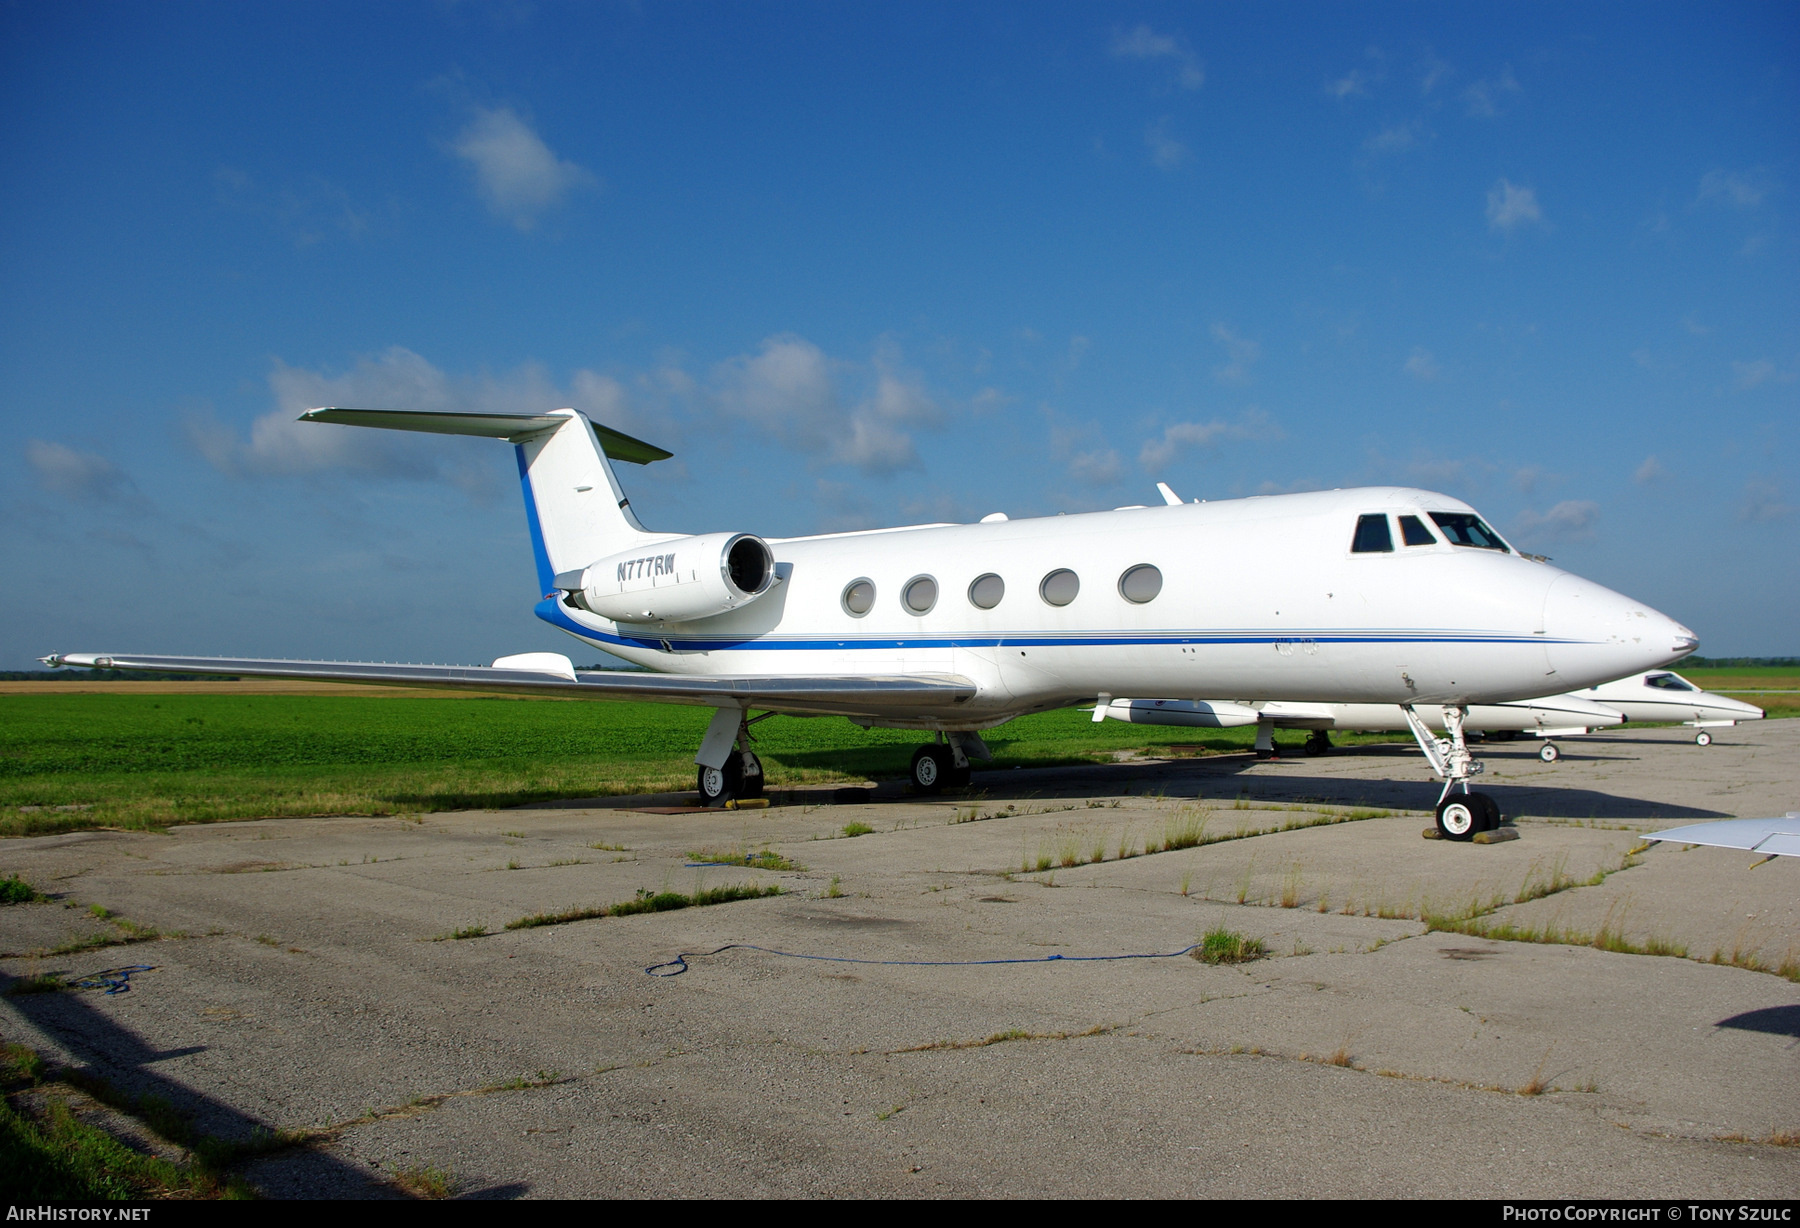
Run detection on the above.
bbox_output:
[556,533,776,623]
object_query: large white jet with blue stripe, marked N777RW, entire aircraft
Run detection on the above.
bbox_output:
[45,409,1697,839]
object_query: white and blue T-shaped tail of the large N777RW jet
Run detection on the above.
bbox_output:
[301,409,673,594]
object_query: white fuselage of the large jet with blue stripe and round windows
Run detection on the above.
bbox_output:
[538,488,1696,729]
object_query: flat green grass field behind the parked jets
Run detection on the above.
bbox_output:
[0,668,1800,835]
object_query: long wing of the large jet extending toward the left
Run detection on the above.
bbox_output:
[31,652,976,717]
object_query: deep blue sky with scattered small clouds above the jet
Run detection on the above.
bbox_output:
[0,4,1800,668]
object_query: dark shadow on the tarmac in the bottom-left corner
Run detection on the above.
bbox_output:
[0,972,405,1197]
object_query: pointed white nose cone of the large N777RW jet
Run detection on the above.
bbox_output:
[1544,574,1699,690]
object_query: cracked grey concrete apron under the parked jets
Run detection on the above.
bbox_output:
[0,720,1800,1197]
